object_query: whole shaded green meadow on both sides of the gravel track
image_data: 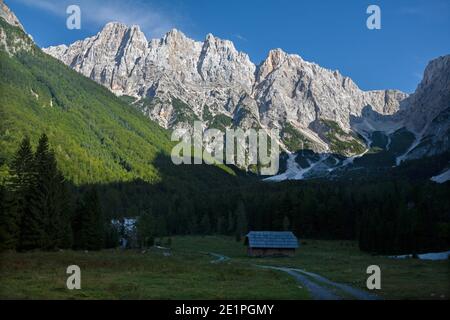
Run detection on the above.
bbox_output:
[0,236,450,299]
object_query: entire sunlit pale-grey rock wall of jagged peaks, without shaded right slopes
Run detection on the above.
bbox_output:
[44,23,408,145]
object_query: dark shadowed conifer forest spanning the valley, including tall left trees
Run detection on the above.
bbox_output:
[0,134,450,254]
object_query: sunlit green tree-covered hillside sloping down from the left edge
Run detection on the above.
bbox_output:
[0,18,237,185]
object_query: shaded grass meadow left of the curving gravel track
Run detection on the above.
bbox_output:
[0,239,308,299]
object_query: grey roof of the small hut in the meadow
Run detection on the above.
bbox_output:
[247,231,298,249]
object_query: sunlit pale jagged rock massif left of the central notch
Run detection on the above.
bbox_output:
[44,23,255,127]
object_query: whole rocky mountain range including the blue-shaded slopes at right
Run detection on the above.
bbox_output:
[0,0,450,180]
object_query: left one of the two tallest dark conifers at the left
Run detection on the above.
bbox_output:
[9,137,43,250]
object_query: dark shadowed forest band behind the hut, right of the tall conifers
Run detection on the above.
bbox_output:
[93,175,450,254]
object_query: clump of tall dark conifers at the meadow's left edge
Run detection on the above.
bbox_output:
[0,134,104,251]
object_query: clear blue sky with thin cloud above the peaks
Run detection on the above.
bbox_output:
[5,0,450,92]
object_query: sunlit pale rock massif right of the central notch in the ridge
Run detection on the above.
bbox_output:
[254,49,407,131]
